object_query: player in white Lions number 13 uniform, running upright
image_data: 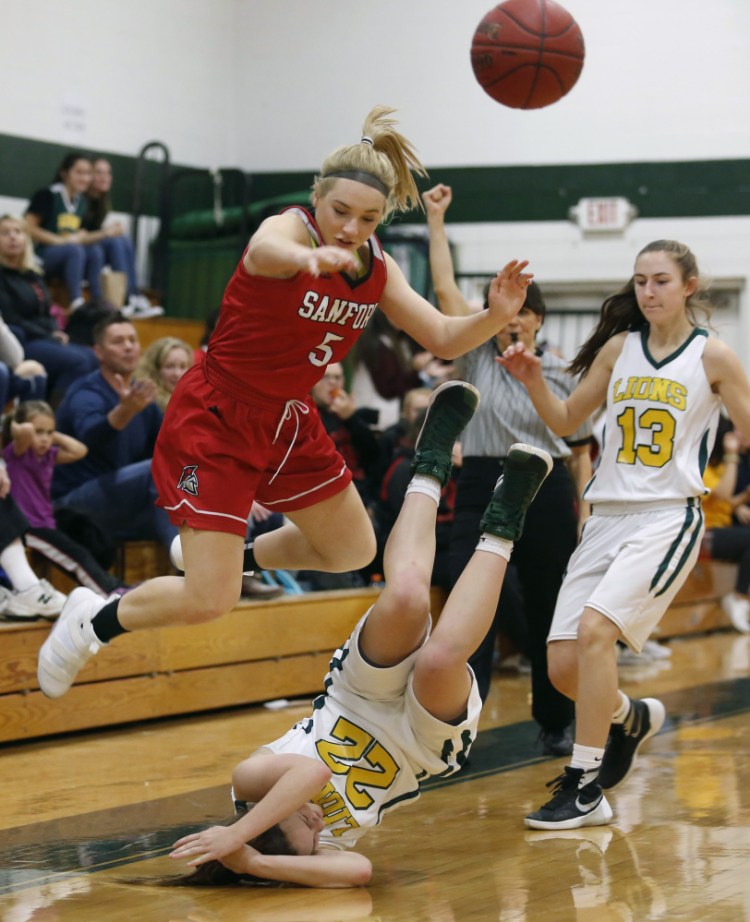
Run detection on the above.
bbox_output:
[499,240,750,829]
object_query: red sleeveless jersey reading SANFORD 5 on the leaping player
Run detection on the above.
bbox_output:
[206,206,387,403]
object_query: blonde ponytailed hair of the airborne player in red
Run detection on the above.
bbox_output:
[312,106,427,220]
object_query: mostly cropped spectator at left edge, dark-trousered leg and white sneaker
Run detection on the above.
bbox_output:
[0,458,66,621]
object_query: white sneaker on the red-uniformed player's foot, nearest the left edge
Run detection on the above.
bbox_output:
[37,588,107,698]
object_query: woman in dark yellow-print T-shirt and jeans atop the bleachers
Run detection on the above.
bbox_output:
[26,152,105,311]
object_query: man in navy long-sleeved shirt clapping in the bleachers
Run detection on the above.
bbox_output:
[52,312,177,548]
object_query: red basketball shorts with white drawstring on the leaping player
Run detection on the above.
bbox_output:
[152,363,352,537]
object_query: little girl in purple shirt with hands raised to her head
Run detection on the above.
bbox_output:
[3,400,125,596]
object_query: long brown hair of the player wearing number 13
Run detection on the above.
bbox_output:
[568,240,713,374]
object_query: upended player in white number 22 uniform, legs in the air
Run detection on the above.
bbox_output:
[172,381,552,887]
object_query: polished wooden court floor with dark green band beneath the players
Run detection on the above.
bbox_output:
[0,632,750,922]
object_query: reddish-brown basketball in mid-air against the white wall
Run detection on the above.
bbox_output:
[471,0,585,109]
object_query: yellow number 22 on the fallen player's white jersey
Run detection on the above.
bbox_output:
[316,717,399,810]
